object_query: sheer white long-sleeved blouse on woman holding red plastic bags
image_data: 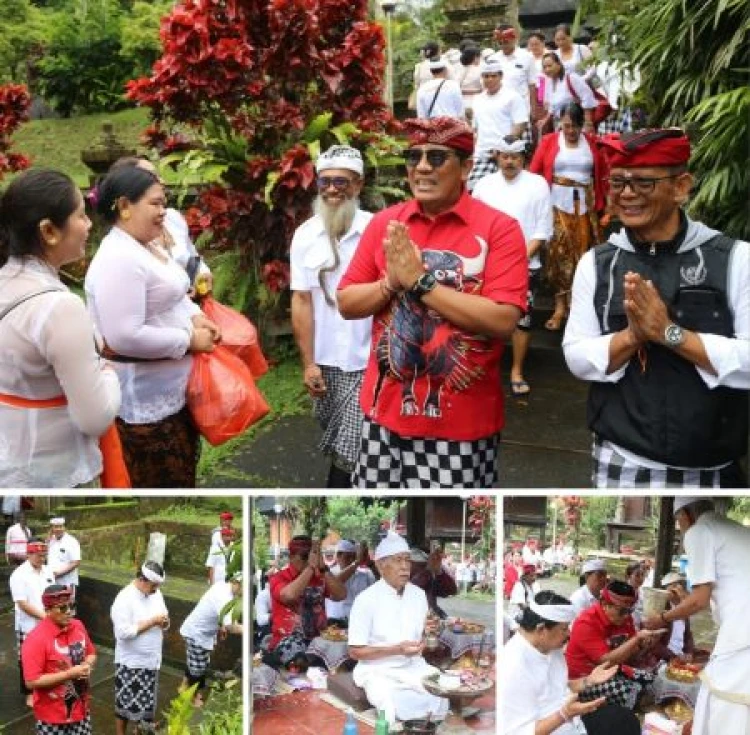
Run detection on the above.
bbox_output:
[86,227,200,424]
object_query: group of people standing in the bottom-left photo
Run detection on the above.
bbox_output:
[5,510,243,735]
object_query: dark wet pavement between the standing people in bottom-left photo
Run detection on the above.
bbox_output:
[0,614,200,735]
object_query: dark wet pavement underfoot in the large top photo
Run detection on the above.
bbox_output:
[204,310,591,488]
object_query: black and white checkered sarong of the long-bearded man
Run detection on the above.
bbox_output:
[313,365,365,472]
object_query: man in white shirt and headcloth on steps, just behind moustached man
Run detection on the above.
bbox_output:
[466,61,529,191]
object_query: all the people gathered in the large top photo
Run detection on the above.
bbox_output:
[0,18,750,489]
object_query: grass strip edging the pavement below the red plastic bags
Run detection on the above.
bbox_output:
[198,355,310,487]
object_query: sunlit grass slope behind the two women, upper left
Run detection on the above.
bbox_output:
[13,108,149,187]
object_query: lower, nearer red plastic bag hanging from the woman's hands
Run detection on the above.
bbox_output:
[187,345,270,446]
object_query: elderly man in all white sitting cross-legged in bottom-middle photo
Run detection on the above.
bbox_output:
[349,531,448,725]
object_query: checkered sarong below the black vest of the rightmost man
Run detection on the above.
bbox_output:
[591,436,736,489]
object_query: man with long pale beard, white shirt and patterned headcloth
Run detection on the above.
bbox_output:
[290,145,372,488]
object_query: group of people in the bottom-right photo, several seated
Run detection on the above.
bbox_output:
[502,496,750,735]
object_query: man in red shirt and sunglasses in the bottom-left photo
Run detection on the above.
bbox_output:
[21,584,96,735]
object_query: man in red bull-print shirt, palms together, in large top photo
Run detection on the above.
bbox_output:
[338,117,528,489]
